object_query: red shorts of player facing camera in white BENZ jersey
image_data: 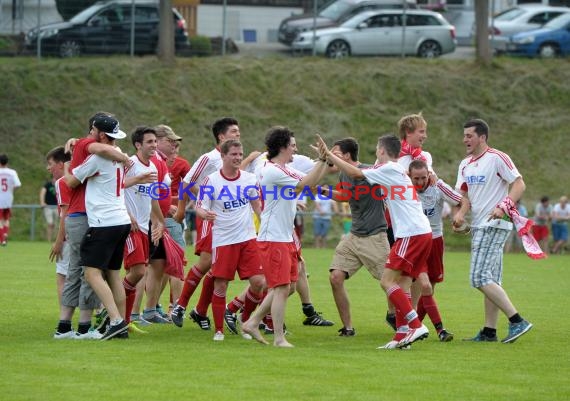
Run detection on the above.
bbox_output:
[212,239,263,281]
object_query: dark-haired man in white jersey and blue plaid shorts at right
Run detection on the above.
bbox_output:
[454,119,532,343]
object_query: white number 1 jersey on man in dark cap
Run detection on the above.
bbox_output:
[71,155,131,227]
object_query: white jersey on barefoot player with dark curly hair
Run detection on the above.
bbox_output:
[257,161,305,242]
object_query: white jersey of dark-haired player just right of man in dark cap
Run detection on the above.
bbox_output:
[125,155,158,234]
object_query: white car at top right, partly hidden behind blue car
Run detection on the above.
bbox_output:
[489,4,570,53]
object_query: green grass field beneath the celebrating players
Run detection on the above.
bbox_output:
[0,242,570,401]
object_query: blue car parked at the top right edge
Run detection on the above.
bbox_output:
[507,13,570,58]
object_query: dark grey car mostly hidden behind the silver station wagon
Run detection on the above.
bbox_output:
[278,0,417,46]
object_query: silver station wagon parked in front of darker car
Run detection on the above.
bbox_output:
[293,10,457,58]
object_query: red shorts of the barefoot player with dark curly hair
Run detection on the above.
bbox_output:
[257,241,299,288]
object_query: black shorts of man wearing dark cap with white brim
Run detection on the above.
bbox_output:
[79,224,131,270]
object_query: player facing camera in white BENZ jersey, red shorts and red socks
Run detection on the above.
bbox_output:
[196,139,265,341]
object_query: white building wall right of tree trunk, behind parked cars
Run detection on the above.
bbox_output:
[197,5,303,43]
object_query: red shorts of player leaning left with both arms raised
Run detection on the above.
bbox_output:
[386,233,432,278]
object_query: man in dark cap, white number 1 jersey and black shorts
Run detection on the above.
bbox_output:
[65,116,131,340]
